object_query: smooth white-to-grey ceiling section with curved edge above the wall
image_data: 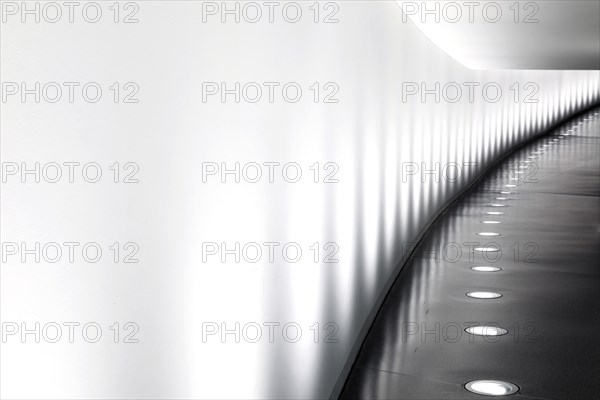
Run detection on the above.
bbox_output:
[398,0,600,70]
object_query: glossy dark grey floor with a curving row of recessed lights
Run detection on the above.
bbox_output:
[341,110,600,399]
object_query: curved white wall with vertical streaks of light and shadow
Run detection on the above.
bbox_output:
[0,1,599,399]
